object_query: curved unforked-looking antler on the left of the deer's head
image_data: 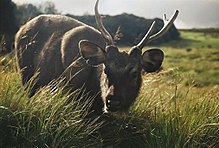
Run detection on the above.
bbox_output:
[95,0,114,45]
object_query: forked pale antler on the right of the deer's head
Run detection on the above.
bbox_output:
[137,10,179,49]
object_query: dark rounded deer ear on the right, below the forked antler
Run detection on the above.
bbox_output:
[141,49,164,72]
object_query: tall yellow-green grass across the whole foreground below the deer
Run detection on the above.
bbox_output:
[0,61,219,147]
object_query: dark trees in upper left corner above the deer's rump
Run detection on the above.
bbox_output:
[0,0,58,55]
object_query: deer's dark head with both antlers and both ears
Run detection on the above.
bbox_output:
[79,0,178,112]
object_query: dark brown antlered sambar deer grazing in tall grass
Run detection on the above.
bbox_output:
[15,0,178,114]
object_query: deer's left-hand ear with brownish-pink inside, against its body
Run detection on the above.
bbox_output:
[78,40,105,66]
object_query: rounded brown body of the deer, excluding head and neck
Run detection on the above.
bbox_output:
[15,15,105,96]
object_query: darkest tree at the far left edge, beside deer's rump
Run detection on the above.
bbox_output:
[0,0,18,54]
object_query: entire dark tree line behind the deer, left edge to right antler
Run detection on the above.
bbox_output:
[0,0,179,54]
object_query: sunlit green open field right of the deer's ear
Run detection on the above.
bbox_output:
[164,29,219,87]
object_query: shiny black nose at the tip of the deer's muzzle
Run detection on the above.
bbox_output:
[106,97,121,112]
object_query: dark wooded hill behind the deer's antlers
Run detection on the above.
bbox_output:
[67,13,179,46]
